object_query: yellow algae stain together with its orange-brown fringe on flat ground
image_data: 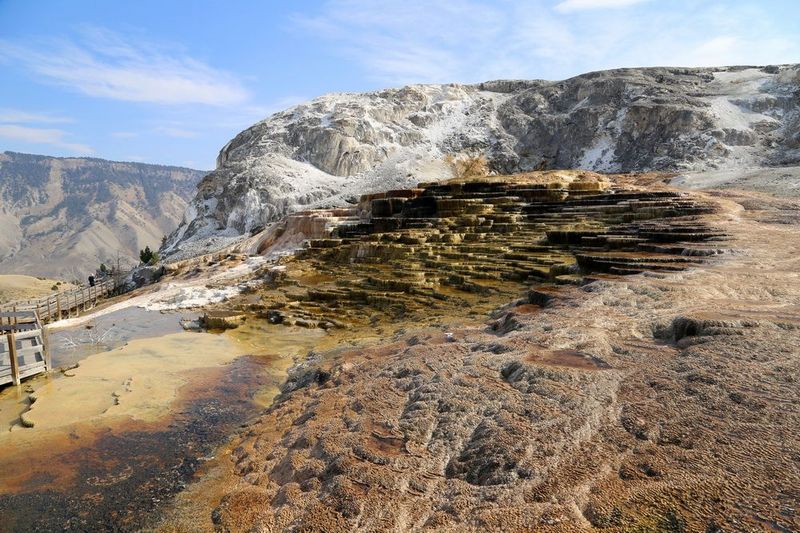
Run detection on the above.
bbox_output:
[0,320,335,495]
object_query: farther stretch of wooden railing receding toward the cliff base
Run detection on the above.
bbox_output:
[0,278,119,324]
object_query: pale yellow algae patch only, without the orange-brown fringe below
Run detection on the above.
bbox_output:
[0,320,335,434]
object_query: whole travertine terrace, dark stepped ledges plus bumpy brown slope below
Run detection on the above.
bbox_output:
[153,172,800,531]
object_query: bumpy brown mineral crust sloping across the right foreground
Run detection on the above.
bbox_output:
[159,185,800,531]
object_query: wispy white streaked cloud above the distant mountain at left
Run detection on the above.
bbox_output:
[0,29,249,106]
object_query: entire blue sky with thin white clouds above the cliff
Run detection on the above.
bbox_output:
[0,0,800,169]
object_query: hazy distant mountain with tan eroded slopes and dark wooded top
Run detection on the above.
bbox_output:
[0,152,205,279]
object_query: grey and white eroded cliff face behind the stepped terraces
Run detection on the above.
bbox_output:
[166,65,800,254]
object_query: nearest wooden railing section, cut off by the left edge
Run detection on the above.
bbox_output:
[0,311,52,385]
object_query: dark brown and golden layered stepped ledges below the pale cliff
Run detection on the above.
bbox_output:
[233,171,725,330]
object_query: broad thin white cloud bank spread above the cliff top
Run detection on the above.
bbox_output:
[294,0,800,85]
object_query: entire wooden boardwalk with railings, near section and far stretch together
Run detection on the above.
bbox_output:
[0,278,120,385]
